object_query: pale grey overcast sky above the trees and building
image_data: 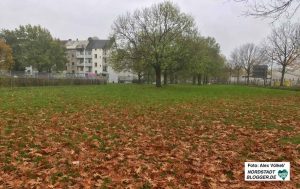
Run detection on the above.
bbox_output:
[0,0,296,56]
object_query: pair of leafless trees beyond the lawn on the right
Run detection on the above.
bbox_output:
[229,22,300,86]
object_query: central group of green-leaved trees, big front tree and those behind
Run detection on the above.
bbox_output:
[110,1,225,87]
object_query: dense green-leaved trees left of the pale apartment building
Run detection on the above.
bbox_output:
[0,25,67,72]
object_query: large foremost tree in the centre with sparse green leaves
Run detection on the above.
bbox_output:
[112,1,194,87]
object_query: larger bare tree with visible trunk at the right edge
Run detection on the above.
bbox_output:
[266,22,300,86]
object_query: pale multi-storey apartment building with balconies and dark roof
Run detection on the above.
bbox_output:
[64,37,134,83]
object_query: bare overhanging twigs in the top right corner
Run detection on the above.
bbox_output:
[234,0,300,20]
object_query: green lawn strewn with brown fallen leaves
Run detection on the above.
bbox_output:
[0,85,300,189]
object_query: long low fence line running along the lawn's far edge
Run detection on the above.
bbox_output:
[0,70,300,88]
